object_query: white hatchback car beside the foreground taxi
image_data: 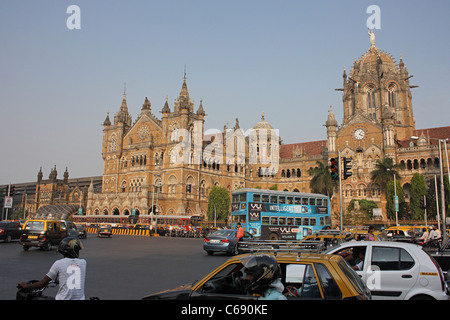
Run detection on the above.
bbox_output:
[326,241,450,300]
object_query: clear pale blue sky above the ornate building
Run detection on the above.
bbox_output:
[0,0,450,184]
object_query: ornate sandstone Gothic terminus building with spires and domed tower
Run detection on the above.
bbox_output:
[74,33,450,224]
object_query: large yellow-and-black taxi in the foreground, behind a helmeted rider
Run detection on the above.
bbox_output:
[142,252,371,300]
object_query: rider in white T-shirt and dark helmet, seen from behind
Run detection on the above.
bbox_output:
[19,237,86,300]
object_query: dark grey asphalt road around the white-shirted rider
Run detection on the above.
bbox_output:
[0,234,229,300]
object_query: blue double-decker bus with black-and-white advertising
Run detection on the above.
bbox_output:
[231,188,331,240]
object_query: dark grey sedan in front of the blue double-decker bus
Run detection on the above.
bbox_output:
[203,229,253,255]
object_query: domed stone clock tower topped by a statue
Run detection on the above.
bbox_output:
[325,33,416,218]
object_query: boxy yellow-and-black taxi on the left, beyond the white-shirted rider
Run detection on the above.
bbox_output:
[20,219,68,251]
